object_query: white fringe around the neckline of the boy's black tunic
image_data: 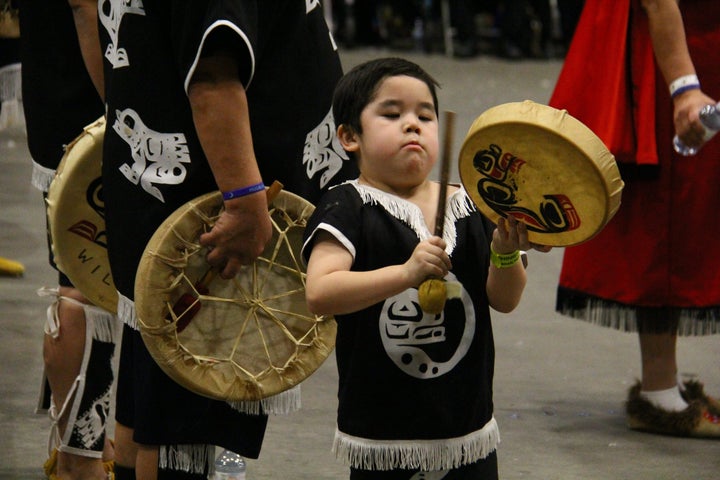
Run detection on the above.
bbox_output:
[347,180,476,255]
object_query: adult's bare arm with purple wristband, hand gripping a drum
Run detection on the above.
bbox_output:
[188,53,272,278]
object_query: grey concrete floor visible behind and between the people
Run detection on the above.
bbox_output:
[0,49,720,480]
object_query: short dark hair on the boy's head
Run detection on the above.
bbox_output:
[332,57,440,137]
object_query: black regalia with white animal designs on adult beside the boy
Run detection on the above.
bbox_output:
[98,0,357,468]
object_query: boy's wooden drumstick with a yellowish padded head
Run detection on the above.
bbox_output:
[418,111,455,315]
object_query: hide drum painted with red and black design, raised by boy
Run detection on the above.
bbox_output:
[459,100,623,246]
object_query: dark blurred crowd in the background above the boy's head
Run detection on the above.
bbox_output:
[326,0,584,59]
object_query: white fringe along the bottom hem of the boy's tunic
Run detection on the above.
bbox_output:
[332,417,500,471]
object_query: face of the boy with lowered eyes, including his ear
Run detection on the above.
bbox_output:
[340,76,439,189]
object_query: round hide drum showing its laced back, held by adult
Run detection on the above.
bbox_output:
[135,191,337,401]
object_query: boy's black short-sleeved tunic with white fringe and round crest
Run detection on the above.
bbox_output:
[303,181,499,471]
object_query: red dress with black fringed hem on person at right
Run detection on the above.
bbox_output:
[550,0,720,335]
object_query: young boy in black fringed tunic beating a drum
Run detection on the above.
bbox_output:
[303,58,544,480]
